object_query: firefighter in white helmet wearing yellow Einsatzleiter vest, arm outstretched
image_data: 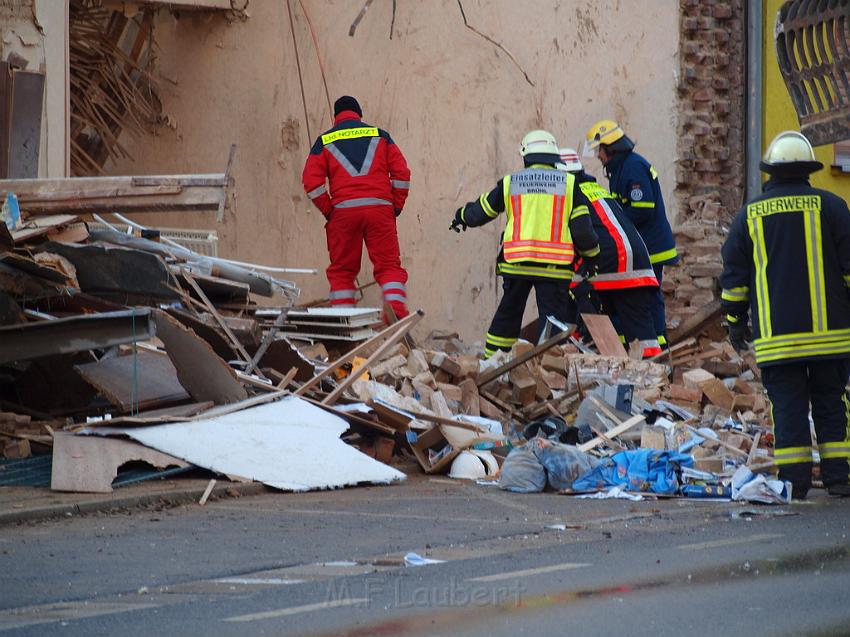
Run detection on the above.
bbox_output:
[450,130,599,357]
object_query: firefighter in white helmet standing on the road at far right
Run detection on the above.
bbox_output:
[720,131,850,498]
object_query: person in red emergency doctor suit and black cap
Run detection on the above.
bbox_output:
[301,95,410,318]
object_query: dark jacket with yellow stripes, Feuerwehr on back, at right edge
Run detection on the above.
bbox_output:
[720,177,850,365]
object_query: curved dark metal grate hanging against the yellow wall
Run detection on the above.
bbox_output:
[774,0,850,146]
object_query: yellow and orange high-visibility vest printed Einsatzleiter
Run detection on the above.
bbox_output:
[503,168,575,265]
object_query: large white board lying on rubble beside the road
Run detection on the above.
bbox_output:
[85,396,406,491]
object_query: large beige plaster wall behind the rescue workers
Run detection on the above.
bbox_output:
[112,0,679,340]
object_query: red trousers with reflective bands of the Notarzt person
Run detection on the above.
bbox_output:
[325,206,409,318]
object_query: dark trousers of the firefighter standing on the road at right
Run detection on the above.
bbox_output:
[761,358,850,487]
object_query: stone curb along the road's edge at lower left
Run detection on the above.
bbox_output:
[0,482,271,526]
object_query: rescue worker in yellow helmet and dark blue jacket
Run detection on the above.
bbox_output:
[585,119,679,348]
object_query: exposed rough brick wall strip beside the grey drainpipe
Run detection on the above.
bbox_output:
[664,0,746,327]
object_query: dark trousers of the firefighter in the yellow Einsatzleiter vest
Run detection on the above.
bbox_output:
[484,276,570,356]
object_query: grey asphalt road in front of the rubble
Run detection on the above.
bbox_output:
[0,476,850,637]
